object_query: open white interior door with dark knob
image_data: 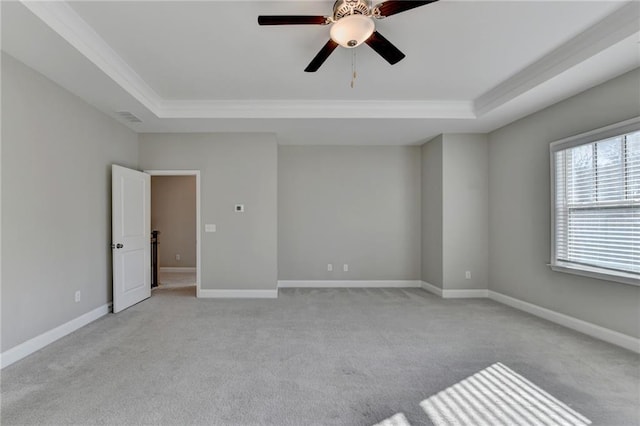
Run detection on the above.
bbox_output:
[111,165,151,313]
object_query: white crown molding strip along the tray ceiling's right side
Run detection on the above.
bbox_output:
[474,1,640,117]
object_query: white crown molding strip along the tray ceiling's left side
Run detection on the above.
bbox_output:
[21,0,161,112]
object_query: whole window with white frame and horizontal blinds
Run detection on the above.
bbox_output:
[551,118,640,285]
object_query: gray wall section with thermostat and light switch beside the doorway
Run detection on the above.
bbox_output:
[139,133,278,290]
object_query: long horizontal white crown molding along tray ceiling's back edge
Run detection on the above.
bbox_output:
[157,100,476,119]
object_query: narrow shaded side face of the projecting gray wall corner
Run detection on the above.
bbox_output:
[421,135,443,288]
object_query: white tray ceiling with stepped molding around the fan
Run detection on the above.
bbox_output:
[1,0,640,145]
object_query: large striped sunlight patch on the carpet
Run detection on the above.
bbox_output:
[420,362,591,426]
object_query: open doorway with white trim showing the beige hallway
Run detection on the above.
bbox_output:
[145,170,201,297]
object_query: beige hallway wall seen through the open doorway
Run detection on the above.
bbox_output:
[151,176,196,268]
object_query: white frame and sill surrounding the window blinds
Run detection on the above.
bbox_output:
[549,117,640,286]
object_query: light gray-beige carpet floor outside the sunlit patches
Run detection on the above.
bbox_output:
[0,283,640,426]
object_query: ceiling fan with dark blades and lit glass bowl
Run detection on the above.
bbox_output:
[258,0,438,72]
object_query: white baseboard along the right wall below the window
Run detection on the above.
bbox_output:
[489,291,640,353]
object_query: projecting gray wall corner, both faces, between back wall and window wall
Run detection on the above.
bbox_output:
[421,134,489,290]
